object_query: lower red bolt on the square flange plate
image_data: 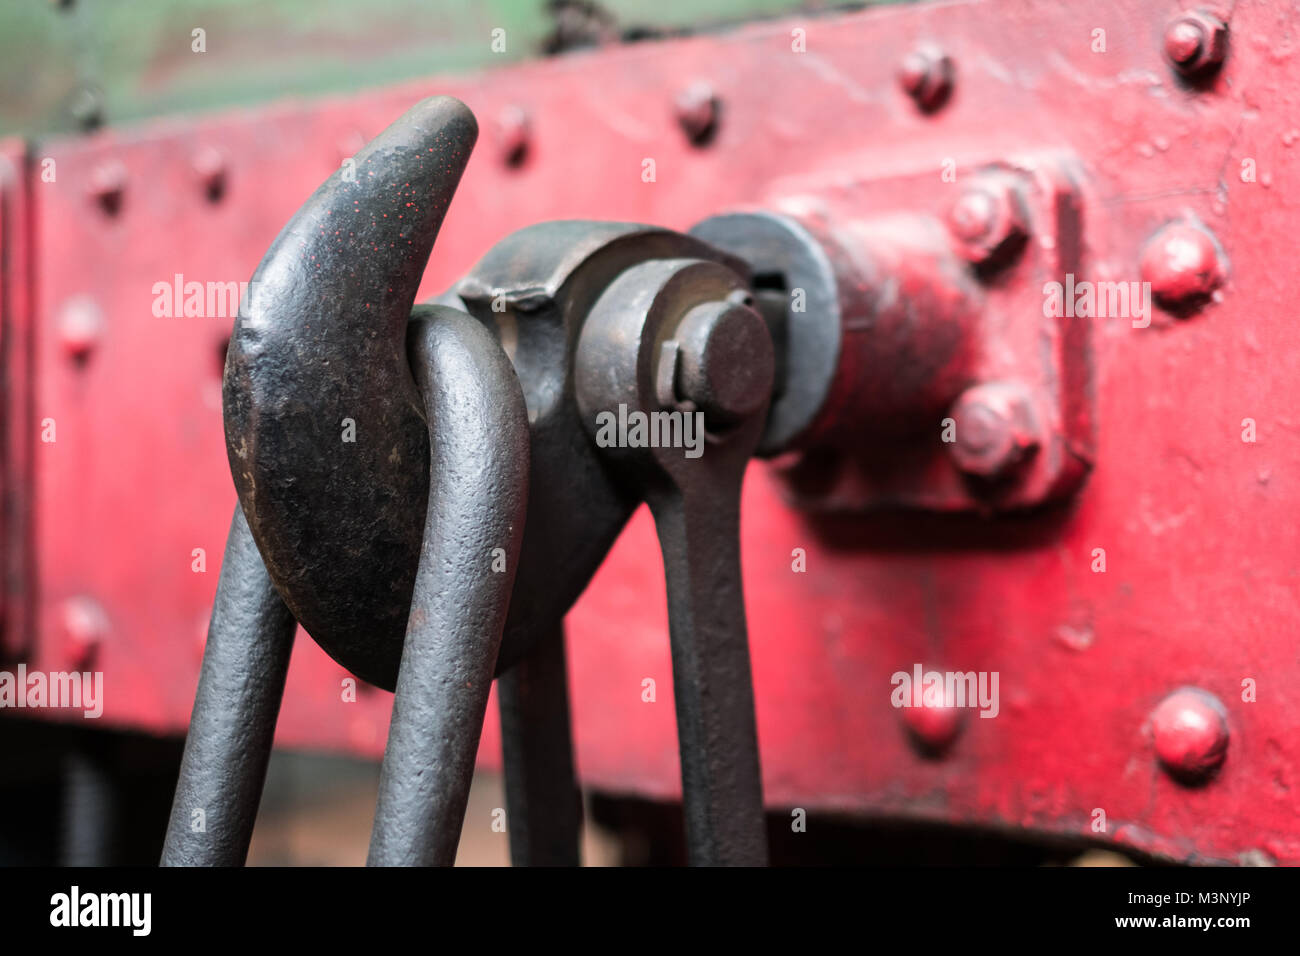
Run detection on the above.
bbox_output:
[948,382,1041,479]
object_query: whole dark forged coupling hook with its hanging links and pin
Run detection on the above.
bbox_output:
[172,98,774,865]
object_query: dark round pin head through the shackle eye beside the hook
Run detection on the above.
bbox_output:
[660,297,775,427]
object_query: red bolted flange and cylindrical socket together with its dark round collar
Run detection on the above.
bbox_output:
[692,158,1092,512]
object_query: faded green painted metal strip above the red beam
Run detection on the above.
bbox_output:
[0,0,883,135]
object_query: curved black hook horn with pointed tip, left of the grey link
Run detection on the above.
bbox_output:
[222,98,478,689]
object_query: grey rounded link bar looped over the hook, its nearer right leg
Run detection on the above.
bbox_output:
[368,306,529,866]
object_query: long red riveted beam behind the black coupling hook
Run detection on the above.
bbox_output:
[4,0,1300,864]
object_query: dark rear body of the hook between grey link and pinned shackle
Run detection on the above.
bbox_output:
[452,220,744,670]
